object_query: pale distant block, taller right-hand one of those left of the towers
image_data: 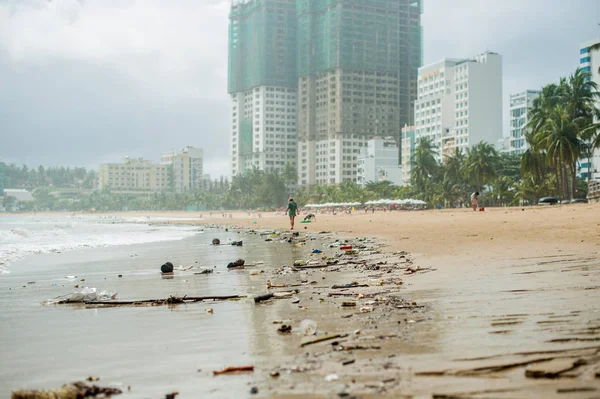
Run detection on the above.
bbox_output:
[160,146,204,193]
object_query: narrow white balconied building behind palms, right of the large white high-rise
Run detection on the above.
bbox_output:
[508,90,540,155]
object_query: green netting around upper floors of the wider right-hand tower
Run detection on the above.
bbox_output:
[296,0,422,76]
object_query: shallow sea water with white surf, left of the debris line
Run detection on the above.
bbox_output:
[0,217,317,398]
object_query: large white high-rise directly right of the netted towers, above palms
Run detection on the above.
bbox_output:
[404,52,502,174]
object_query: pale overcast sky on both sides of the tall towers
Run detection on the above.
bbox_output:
[0,0,600,177]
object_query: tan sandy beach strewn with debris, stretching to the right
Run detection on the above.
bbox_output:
[4,204,600,398]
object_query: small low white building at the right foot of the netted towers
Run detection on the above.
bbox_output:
[357,137,403,186]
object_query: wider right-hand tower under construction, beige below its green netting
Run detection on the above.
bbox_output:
[296,0,422,186]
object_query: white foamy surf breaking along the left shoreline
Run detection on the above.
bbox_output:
[0,215,198,273]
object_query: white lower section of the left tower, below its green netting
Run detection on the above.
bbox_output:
[231,86,297,176]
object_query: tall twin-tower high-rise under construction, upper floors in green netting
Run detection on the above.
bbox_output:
[229,0,422,186]
